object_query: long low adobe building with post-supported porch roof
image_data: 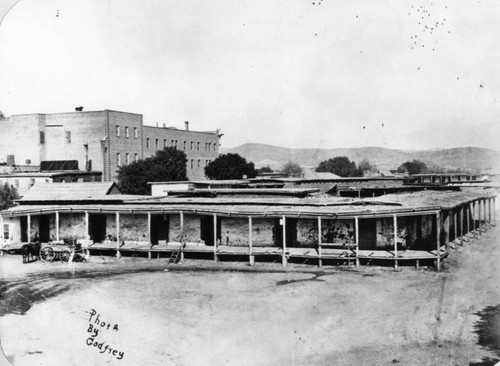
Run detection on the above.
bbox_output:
[0,182,496,270]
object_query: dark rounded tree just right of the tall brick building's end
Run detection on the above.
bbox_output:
[205,154,257,179]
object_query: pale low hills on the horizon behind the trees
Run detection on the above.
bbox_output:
[223,143,500,171]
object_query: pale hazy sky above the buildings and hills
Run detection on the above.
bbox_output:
[0,0,500,150]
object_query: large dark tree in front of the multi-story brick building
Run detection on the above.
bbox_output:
[117,147,187,195]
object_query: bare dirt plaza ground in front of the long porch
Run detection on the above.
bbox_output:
[0,216,500,366]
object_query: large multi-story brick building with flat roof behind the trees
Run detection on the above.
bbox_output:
[0,108,222,181]
